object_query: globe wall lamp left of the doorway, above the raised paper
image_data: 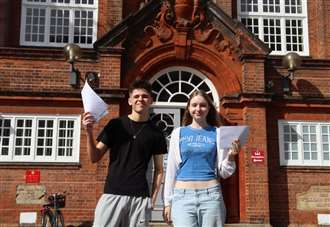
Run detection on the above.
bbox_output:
[64,43,81,88]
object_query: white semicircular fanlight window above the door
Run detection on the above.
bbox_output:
[150,66,219,107]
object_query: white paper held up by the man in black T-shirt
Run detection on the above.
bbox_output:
[81,81,108,121]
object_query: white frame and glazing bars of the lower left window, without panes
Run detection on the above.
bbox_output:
[0,114,81,163]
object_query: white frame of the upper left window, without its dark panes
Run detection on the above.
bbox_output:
[20,0,99,48]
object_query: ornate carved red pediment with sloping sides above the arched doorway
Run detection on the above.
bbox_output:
[95,0,270,79]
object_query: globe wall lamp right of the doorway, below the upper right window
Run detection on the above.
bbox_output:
[282,52,301,95]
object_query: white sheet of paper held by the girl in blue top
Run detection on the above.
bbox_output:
[220,125,249,149]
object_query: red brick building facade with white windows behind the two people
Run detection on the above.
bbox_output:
[0,0,330,227]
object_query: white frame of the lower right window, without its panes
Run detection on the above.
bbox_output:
[278,120,330,167]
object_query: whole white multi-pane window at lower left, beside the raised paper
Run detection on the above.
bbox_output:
[0,115,80,162]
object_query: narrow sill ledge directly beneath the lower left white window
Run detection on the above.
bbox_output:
[0,162,81,170]
